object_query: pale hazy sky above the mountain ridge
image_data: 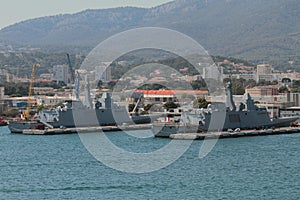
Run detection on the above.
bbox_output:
[0,0,171,29]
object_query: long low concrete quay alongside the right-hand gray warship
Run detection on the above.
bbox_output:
[169,127,300,140]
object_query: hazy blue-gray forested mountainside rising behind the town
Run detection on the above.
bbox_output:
[0,0,300,68]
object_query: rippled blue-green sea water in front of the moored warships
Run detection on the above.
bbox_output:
[0,127,300,200]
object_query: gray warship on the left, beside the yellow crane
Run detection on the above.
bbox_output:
[8,93,158,133]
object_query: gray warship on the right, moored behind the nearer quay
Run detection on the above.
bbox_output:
[153,82,298,137]
